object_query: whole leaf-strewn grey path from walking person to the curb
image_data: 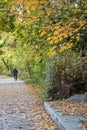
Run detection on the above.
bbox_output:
[0,78,57,130]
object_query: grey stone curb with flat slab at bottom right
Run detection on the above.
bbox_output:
[44,102,86,130]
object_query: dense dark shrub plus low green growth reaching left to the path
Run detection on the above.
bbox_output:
[24,51,87,100]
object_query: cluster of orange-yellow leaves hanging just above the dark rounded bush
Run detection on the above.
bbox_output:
[45,18,86,52]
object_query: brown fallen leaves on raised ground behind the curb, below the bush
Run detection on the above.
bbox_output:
[49,100,87,130]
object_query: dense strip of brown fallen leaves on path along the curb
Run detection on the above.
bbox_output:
[25,86,58,130]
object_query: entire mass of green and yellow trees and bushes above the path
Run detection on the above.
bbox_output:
[0,0,87,98]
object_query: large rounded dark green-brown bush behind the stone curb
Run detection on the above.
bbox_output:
[47,51,87,100]
